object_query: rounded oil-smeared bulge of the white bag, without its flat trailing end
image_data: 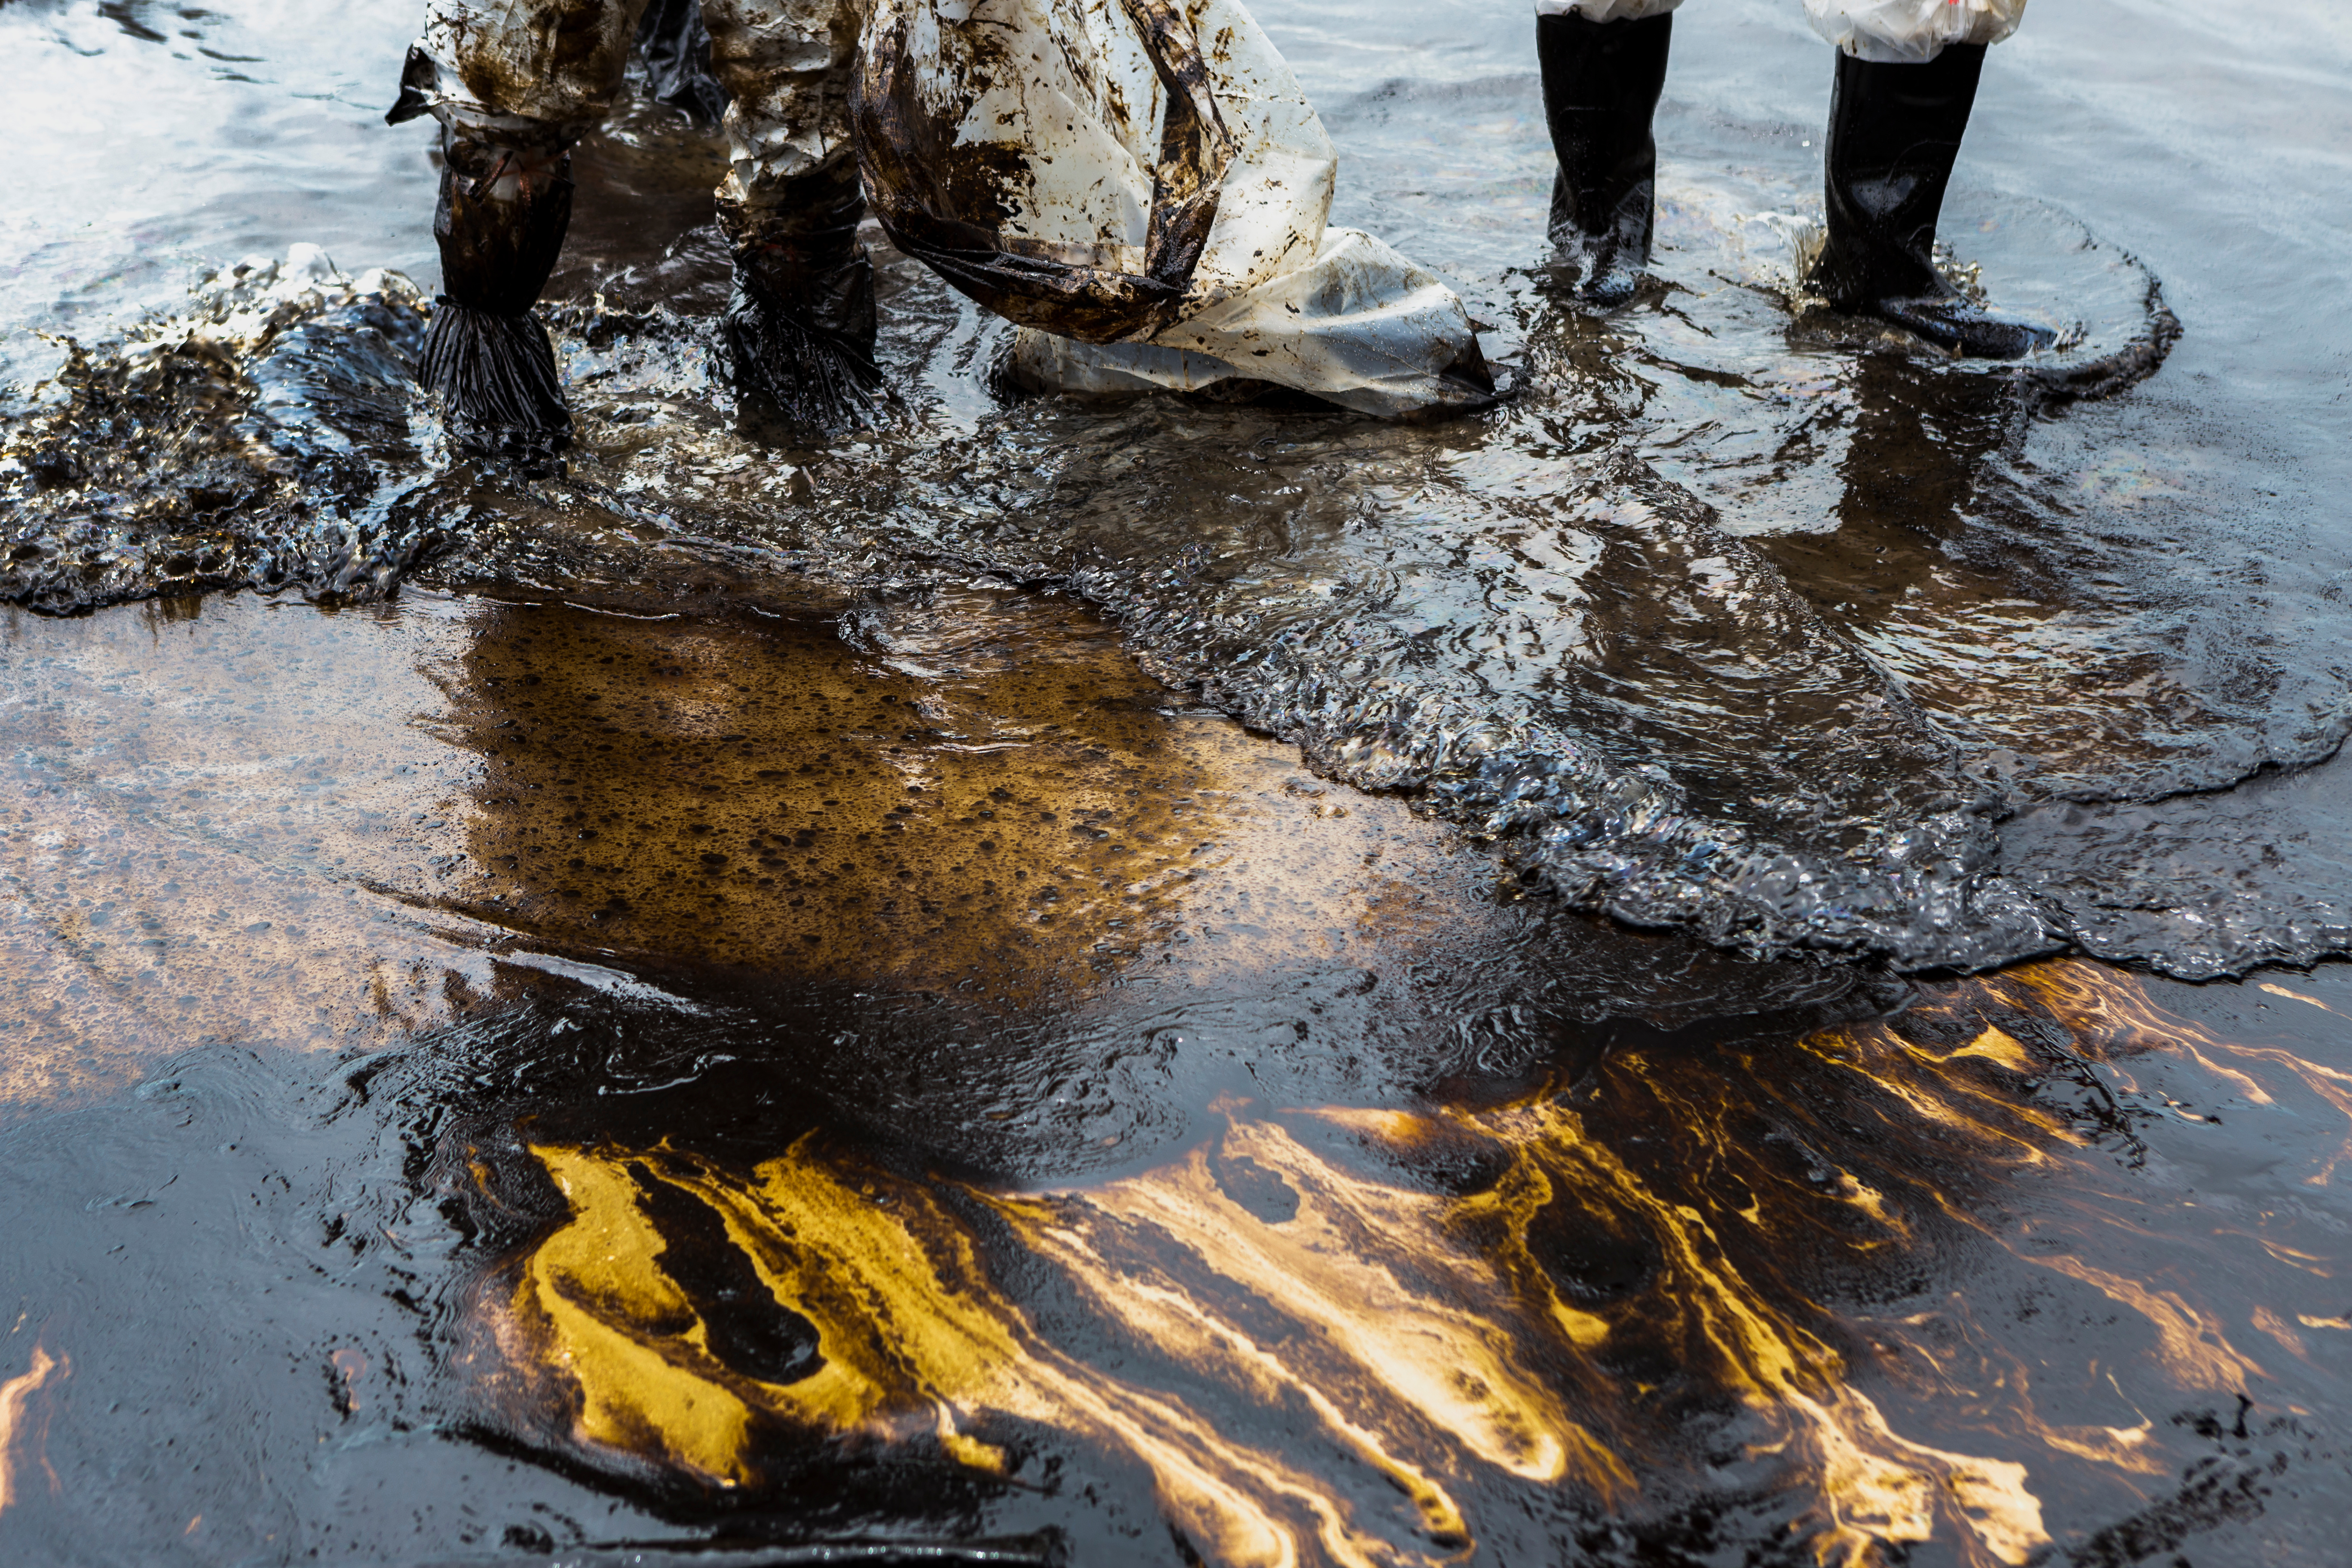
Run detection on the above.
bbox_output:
[858,0,1338,343]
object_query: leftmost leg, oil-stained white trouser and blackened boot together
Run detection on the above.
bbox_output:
[386,0,644,456]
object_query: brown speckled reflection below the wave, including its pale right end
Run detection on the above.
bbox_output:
[440,592,1496,1006]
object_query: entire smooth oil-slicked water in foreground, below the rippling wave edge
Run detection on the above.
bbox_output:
[0,588,2352,1563]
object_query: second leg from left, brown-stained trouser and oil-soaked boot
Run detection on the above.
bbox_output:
[703,0,882,432]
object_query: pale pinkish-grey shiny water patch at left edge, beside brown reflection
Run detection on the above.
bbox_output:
[0,600,489,1112]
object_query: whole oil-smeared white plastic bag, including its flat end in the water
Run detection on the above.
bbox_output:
[856,0,1489,414]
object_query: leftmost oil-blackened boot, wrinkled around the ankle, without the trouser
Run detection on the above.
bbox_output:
[416,134,572,456]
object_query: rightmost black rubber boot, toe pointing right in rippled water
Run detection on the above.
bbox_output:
[1809,45,2056,360]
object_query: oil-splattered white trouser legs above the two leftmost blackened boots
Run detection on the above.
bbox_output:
[402,0,866,209]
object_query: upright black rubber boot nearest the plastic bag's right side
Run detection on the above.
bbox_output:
[1536,12,1675,306]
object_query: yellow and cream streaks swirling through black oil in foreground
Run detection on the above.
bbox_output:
[477,964,2333,1568]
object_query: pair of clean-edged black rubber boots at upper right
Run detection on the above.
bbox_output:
[1536,12,2051,360]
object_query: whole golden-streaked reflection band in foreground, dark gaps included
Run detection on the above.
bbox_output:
[449,964,2352,1563]
